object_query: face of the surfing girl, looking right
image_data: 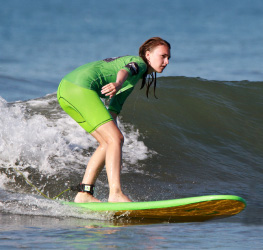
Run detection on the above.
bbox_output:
[145,45,170,73]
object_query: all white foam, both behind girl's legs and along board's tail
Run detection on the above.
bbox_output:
[0,94,154,216]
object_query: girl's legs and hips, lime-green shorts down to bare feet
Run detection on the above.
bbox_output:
[57,80,130,202]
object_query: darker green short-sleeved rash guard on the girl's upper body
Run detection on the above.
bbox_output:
[63,56,147,114]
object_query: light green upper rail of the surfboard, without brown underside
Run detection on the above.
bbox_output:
[63,195,246,211]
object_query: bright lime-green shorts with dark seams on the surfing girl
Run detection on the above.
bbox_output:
[57,79,113,133]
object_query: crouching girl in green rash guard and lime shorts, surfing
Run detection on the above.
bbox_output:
[57,37,171,202]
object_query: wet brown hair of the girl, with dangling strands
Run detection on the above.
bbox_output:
[139,37,171,98]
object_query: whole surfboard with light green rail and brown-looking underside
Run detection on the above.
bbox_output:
[63,195,246,222]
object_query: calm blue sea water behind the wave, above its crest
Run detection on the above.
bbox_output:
[0,0,263,100]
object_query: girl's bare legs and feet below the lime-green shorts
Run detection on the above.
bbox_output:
[75,121,131,202]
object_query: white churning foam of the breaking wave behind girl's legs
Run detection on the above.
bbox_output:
[0,95,154,175]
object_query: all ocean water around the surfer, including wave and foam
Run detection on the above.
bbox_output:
[0,0,263,249]
